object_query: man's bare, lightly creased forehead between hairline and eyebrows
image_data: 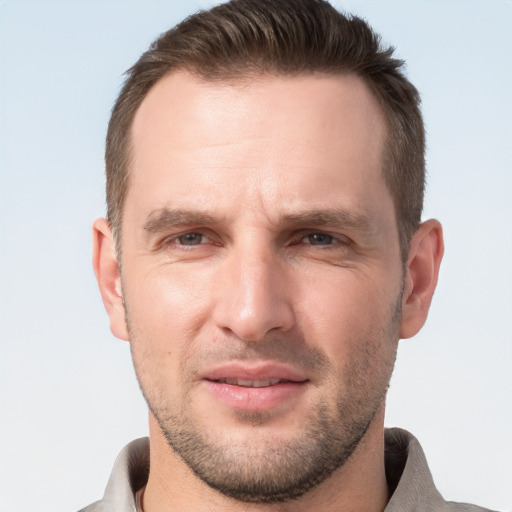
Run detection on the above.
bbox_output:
[126,71,386,224]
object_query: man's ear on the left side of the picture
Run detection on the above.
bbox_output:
[92,219,128,340]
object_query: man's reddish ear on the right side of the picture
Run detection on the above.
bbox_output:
[400,220,444,338]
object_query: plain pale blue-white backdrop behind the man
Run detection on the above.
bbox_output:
[0,0,512,512]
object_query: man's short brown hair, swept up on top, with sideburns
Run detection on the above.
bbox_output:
[105,0,425,260]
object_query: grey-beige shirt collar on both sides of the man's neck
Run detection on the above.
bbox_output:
[79,428,492,512]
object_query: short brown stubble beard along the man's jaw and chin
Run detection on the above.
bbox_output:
[127,295,401,503]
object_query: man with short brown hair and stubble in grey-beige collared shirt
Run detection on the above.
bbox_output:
[85,0,492,512]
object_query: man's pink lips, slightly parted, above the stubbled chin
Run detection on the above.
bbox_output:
[201,363,309,412]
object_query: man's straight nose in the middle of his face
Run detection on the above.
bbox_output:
[213,244,295,341]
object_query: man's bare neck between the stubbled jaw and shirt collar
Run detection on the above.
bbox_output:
[143,404,389,512]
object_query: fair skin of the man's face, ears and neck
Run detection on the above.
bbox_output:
[94,71,443,512]
